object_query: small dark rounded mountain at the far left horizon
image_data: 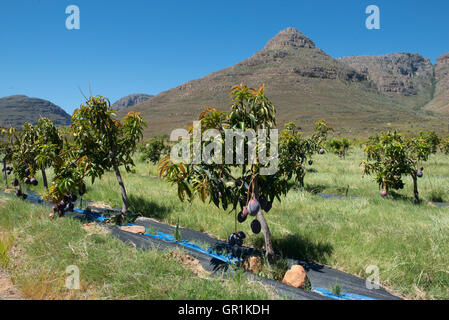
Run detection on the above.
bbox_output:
[0,95,71,128]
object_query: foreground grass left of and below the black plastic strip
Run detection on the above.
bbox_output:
[0,196,275,299]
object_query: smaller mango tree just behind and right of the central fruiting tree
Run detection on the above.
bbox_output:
[279,120,332,188]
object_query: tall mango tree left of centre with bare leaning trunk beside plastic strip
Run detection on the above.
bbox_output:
[71,96,146,223]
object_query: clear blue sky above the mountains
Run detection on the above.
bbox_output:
[0,0,449,113]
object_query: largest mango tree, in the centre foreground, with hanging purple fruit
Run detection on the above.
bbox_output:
[159,84,289,263]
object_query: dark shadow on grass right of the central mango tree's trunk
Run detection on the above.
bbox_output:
[255,235,333,264]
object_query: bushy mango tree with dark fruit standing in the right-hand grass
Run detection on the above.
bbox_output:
[361,131,432,203]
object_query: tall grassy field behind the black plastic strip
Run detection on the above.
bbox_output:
[0,149,449,299]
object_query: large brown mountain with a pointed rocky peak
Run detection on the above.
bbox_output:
[120,28,447,137]
